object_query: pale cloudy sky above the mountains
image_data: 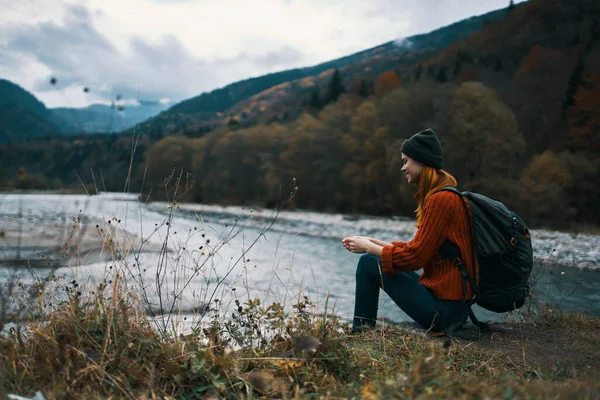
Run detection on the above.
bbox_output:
[0,0,518,107]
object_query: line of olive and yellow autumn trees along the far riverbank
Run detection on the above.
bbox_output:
[142,82,600,228]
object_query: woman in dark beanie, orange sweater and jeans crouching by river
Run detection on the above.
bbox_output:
[342,129,474,331]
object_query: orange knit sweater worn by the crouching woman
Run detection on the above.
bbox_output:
[381,192,476,300]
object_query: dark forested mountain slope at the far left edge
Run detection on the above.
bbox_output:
[0,79,62,143]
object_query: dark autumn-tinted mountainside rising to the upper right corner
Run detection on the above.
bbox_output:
[186,0,600,155]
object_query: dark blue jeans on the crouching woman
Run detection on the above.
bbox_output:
[352,254,468,331]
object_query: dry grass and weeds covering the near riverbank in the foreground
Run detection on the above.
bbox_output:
[0,280,600,399]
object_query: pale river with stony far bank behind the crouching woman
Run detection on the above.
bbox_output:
[0,193,600,330]
